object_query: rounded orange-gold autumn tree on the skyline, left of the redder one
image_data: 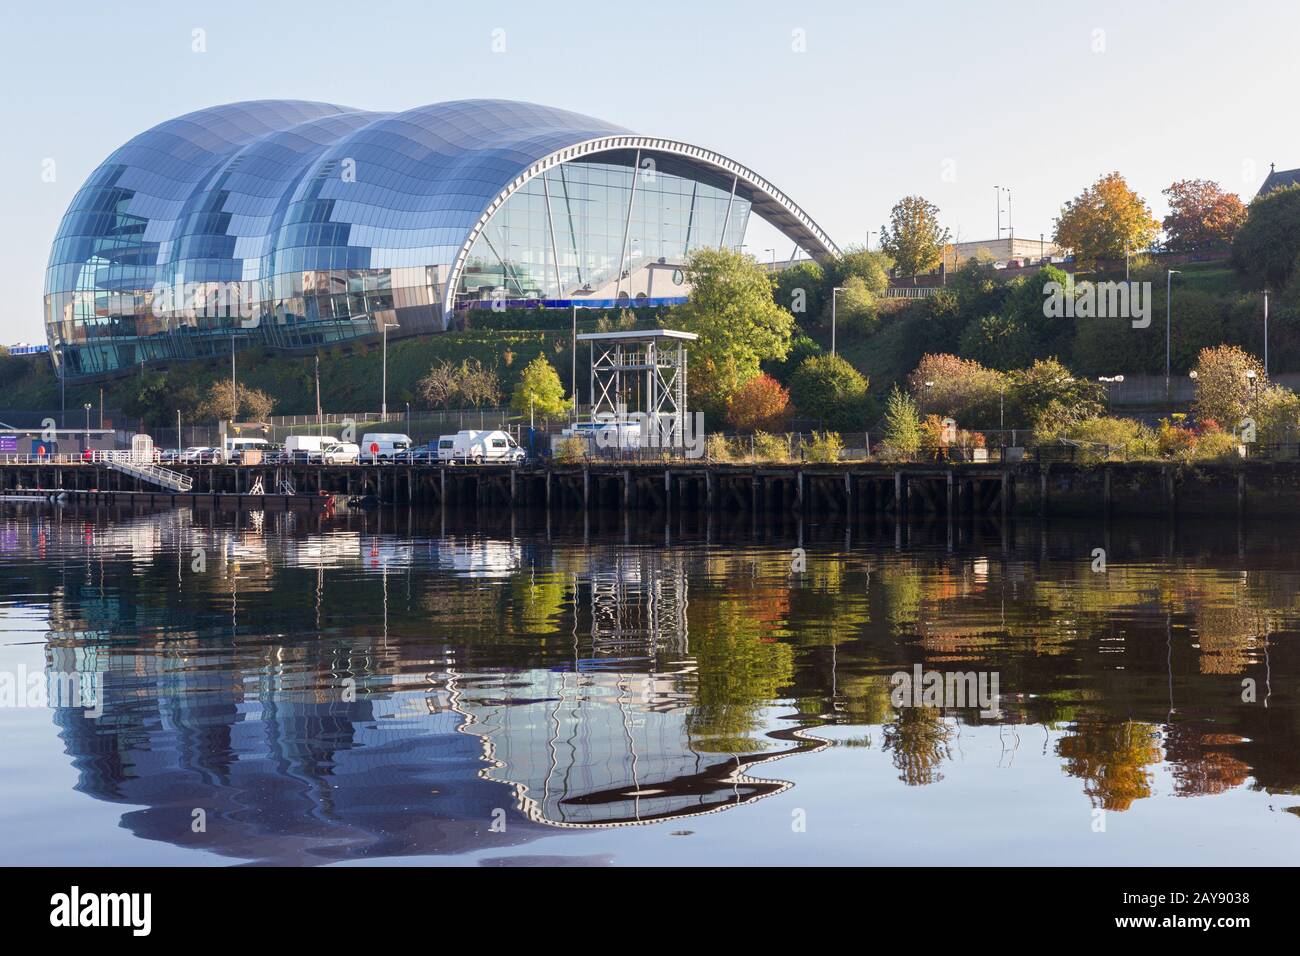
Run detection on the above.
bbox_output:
[1052,173,1160,267]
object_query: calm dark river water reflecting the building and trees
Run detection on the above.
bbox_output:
[0,506,1300,865]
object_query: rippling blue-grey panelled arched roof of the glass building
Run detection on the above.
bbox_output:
[47,100,837,312]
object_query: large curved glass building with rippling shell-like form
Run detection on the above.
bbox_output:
[46,100,837,377]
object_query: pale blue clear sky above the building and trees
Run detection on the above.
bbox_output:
[0,0,1300,343]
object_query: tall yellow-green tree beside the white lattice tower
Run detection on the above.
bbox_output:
[671,248,794,414]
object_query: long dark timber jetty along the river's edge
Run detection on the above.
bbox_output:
[0,457,1300,518]
